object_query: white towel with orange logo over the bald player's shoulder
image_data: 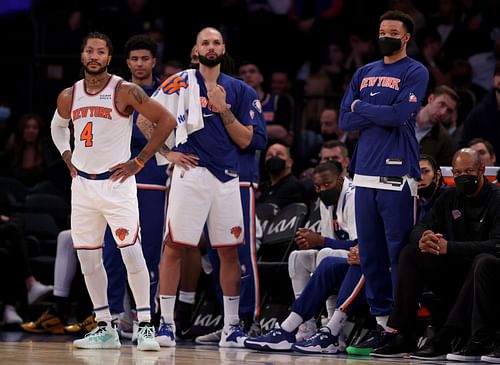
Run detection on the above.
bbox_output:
[152,69,204,165]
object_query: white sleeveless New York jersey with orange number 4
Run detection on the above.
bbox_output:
[71,75,132,174]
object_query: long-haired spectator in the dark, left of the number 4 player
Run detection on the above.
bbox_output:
[7,114,56,187]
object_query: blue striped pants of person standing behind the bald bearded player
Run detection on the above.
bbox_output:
[205,182,260,319]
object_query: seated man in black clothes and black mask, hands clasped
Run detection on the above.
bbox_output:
[371,148,500,357]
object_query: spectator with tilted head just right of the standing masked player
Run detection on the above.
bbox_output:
[415,85,460,166]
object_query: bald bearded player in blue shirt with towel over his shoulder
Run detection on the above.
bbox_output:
[153,28,260,347]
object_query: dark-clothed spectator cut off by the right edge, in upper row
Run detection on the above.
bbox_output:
[460,61,500,166]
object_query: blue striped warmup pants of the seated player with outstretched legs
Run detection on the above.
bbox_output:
[292,256,365,321]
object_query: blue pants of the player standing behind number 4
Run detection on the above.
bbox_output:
[103,188,165,314]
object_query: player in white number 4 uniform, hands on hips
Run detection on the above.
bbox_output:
[51,33,176,350]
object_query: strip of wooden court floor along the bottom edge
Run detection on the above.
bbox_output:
[0,332,485,365]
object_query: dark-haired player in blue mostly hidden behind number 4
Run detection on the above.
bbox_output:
[103,35,167,330]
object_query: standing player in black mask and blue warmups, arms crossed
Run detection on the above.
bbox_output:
[340,11,429,352]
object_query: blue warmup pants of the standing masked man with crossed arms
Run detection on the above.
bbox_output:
[355,184,415,316]
